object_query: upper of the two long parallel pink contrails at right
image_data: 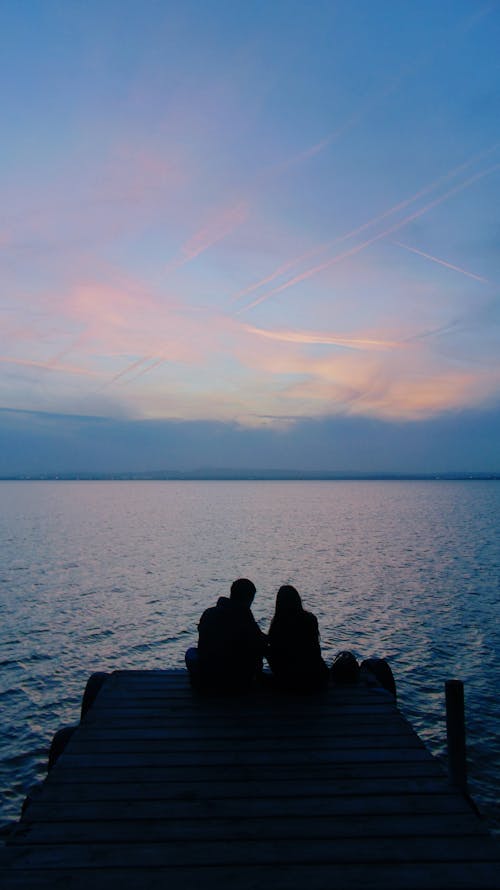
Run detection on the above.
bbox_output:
[232,142,500,308]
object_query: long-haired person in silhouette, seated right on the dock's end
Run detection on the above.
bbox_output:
[267,584,328,692]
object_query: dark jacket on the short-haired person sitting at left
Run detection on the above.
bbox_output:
[198,596,267,687]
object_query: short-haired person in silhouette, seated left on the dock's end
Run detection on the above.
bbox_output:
[186,578,267,692]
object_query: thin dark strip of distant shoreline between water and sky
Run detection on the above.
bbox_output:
[0,469,500,482]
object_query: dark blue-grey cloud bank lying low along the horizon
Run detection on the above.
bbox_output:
[0,402,500,476]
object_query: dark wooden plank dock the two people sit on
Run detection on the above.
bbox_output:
[0,671,500,890]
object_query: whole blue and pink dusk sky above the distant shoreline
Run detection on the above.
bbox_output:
[0,0,500,475]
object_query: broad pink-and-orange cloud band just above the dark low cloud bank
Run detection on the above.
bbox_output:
[0,260,500,427]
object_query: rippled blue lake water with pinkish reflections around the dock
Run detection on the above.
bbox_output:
[0,481,500,833]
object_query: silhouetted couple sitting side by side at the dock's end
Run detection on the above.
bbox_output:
[186,578,328,692]
